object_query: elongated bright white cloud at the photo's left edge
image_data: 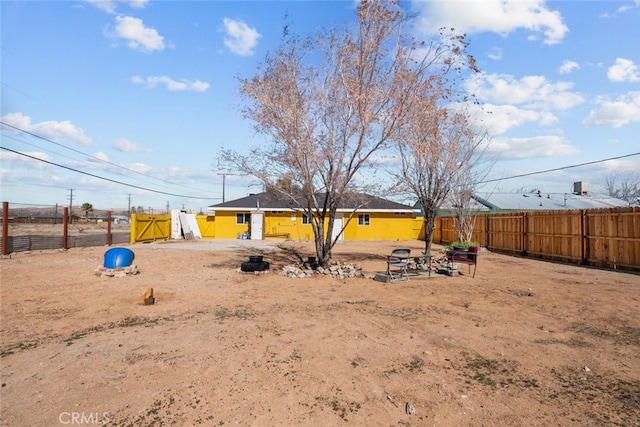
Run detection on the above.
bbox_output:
[1,113,93,145]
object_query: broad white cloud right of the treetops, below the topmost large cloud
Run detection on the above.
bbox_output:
[467,74,584,110]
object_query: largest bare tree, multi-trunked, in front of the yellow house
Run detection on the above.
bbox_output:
[223,1,468,265]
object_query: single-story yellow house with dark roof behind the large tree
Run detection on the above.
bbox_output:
[207,192,423,240]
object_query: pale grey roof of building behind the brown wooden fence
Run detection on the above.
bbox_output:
[473,192,629,211]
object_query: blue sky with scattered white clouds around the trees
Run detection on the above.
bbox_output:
[0,0,640,213]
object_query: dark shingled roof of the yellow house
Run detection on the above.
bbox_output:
[207,192,415,213]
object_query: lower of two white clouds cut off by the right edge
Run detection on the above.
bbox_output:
[582,92,640,128]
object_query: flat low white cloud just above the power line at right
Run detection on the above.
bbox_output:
[489,135,578,160]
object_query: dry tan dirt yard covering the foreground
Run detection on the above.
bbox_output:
[0,241,640,426]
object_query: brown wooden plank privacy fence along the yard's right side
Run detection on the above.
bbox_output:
[434,207,640,271]
